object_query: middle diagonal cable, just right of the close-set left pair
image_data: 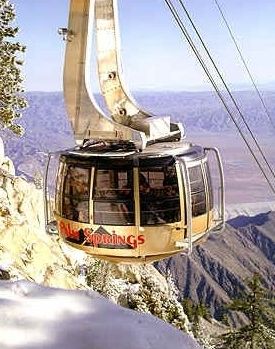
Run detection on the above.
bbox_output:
[178,0,275,179]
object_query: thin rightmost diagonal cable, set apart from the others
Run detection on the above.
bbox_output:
[213,0,275,129]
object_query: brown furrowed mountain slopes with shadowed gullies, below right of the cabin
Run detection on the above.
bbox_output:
[157,207,275,324]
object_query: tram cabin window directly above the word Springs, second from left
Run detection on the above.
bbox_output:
[93,169,135,226]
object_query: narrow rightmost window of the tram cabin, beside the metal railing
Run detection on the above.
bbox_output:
[188,165,206,217]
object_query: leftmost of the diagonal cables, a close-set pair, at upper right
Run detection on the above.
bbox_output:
[164,0,275,193]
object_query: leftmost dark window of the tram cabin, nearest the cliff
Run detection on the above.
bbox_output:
[62,165,90,223]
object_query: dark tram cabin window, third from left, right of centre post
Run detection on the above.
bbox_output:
[139,166,180,225]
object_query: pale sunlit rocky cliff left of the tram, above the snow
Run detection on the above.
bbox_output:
[0,147,82,288]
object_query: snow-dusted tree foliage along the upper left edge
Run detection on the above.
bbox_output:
[0,0,27,135]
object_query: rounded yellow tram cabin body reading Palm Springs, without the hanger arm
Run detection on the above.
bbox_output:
[47,142,224,262]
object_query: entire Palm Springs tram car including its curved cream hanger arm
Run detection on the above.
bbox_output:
[44,0,224,263]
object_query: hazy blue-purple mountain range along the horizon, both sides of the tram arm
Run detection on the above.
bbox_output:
[1,91,275,151]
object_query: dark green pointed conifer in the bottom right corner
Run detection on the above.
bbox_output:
[216,274,275,349]
